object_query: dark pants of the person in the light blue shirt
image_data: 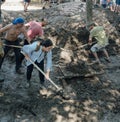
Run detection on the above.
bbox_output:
[27,60,45,84]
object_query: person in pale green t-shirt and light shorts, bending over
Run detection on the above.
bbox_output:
[88,23,110,64]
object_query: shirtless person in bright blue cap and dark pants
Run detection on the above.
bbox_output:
[0,17,30,74]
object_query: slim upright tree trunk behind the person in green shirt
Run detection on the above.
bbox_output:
[86,0,93,25]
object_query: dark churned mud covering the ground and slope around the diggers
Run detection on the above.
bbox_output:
[0,2,120,122]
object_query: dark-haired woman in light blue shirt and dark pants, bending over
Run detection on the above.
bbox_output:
[21,39,53,88]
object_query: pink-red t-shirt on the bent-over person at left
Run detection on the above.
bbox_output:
[26,21,44,39]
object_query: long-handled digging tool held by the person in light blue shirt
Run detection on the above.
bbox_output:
[21,51,69,99]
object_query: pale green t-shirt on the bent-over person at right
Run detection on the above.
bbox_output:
[90,26,108,46]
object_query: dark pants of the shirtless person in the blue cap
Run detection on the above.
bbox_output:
[0,40,21,71]
